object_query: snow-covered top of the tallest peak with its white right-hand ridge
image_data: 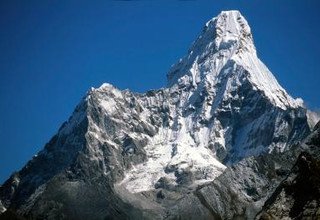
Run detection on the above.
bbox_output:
[168,11,303,109]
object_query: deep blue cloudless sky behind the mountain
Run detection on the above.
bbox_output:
[0,0,320,182]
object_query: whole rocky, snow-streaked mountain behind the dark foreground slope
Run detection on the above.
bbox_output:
[0,11,313,219]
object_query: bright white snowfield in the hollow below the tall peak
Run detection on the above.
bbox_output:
[119,120,225,193]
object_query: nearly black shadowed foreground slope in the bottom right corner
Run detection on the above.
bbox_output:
[257,123,320,219]
